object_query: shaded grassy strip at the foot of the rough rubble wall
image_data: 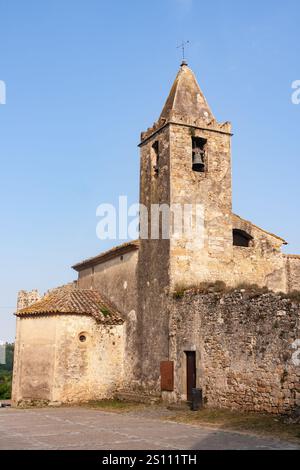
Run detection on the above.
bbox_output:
[169,408,300,443]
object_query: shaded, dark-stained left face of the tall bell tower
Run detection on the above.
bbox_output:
[137,127,170,392]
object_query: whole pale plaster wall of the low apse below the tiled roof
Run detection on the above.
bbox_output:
[13,315,124,403]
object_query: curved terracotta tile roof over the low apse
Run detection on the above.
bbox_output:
[16,289,124,325]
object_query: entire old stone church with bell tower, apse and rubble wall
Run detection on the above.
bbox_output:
[13,61,300,413]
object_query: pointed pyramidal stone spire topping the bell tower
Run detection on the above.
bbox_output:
[160,62,214,120]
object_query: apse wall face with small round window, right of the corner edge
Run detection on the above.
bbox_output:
[53,315,124,401]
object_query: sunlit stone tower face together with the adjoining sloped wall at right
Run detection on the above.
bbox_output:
[169,124,288,292]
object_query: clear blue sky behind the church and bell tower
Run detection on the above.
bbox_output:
[0,0,300,340]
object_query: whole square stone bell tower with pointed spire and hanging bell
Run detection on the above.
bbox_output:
[138,62,233,392]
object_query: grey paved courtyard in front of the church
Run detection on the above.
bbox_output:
[0,408,300,450]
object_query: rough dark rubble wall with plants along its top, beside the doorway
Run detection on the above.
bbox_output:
[170,290,300,413]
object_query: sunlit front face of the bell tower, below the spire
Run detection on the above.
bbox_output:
[170,124,233,286]
